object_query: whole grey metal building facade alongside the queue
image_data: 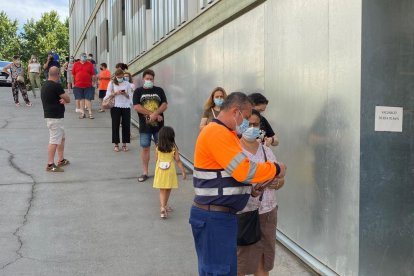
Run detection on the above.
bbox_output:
[69,0,414,275]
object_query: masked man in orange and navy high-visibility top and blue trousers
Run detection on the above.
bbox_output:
[189,92,286,276]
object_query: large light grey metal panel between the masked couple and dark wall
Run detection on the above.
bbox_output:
[265,0,361,275]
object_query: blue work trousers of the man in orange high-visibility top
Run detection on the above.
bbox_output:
[189,206,237,276]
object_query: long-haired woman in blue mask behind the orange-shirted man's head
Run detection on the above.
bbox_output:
[200,87,227,130]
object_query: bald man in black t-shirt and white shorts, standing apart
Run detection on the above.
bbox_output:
[40,66,70,172]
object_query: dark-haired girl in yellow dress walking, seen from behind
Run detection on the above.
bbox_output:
[153,126,186,218]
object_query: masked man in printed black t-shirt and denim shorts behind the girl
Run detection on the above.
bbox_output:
[132,69,168,182]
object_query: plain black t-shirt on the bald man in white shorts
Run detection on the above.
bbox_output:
[40,80,65,119]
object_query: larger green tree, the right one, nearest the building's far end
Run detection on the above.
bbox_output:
[21,11,69,63]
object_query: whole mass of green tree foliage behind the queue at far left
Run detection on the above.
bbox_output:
[0,11,69,62]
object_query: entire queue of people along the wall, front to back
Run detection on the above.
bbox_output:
[12,48,286,275]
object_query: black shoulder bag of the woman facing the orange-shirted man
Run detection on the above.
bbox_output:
[236,146,267,246]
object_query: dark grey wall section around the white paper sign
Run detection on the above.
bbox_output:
[360,0,414,276]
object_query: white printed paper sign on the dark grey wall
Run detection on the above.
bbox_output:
[375,106,403,132]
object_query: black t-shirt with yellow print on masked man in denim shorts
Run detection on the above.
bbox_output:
[132,86,167,133]
